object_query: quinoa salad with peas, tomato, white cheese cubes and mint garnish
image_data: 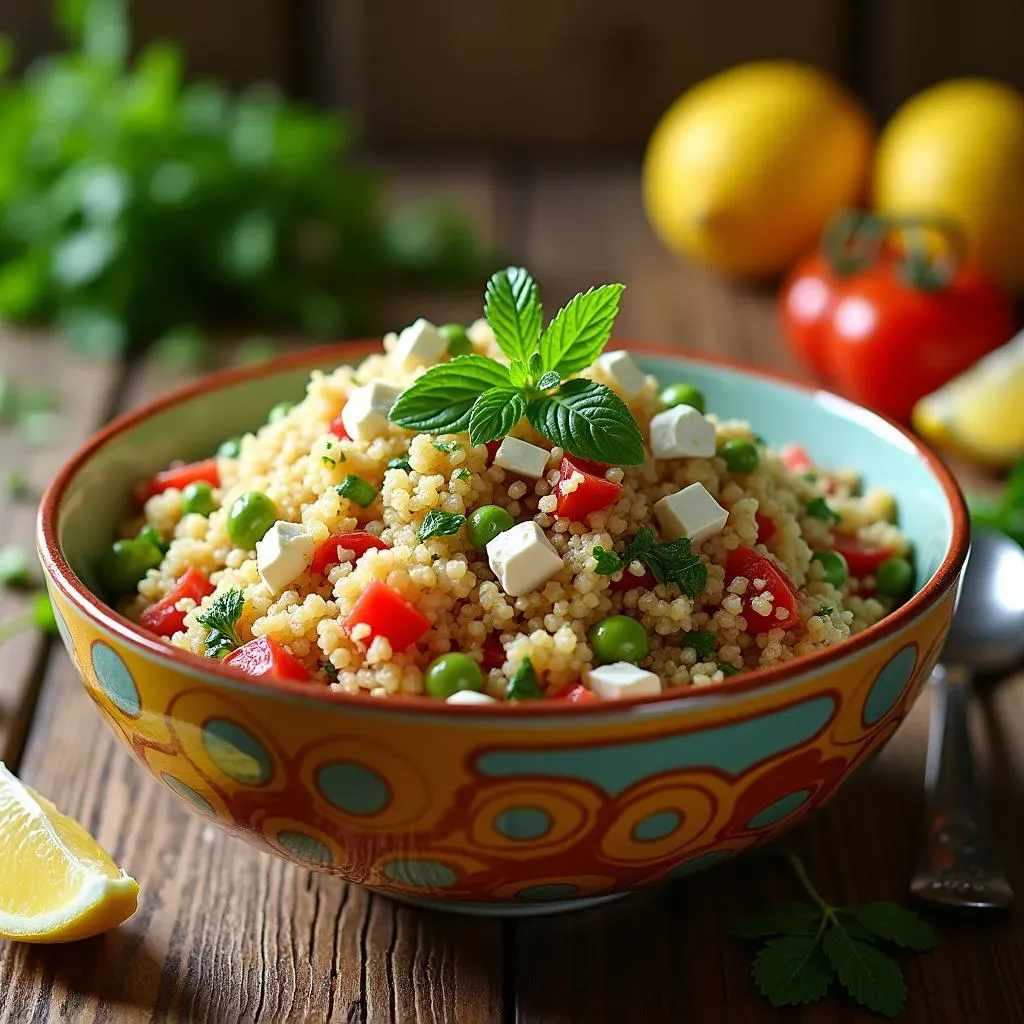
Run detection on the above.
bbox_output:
[100,267,913,703]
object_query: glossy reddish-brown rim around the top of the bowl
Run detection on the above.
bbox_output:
[37,339,970,717]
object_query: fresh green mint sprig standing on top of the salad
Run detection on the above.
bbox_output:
[390,267,644,466]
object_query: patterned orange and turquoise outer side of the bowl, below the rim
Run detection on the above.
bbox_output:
[44,588,954,910]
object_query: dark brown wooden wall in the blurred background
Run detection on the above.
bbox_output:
[0,0,1024,154]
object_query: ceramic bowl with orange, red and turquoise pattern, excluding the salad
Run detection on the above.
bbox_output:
[39,343,968,913]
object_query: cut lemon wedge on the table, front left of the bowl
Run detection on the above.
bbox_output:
[0,762,138,942]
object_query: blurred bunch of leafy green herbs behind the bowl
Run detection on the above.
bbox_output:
[0,0,493,353]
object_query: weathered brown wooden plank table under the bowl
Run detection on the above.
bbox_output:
[0,166,1024,1024]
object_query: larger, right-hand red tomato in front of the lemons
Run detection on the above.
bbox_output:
[822,264,1014,421]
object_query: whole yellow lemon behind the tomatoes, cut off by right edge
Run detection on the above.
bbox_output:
[874,79,1024,291]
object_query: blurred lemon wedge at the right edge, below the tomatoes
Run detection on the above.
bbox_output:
[913,332,1024,466]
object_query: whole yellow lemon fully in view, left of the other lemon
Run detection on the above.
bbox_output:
[643,60,872,276]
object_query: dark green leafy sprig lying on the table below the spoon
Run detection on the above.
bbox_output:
[730,853,938,1017]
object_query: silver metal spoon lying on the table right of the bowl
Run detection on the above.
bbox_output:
[910,529,1024,907]
